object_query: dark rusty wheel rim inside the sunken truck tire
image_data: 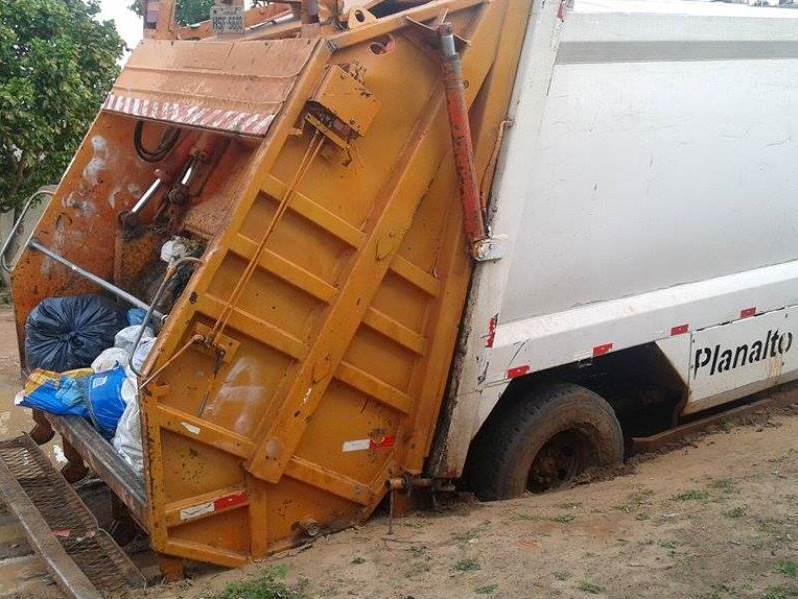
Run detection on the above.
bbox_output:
[527,430,590,493]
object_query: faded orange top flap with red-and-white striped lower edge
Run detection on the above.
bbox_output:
[103,38,317,137]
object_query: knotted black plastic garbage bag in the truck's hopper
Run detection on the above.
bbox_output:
[25,295,127,372]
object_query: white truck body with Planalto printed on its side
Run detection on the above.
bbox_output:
[435,0,798,475]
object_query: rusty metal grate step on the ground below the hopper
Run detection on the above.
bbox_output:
[0,435,146,599]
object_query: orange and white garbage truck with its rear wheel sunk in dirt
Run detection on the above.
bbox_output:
[0,0,798,584]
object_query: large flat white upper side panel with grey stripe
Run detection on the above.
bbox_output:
[500,14,798,323]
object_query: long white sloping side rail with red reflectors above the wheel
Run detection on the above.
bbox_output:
[484,261,798,385]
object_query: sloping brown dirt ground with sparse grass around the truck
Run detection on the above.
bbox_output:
[0,304,798,599]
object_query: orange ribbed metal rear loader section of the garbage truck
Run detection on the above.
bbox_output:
[14,0,529,566]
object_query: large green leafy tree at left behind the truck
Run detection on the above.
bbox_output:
[0,0,125,212]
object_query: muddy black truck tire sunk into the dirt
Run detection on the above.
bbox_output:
[469,383,623,501]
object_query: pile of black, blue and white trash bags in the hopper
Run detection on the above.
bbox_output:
[15,295,156,476]
